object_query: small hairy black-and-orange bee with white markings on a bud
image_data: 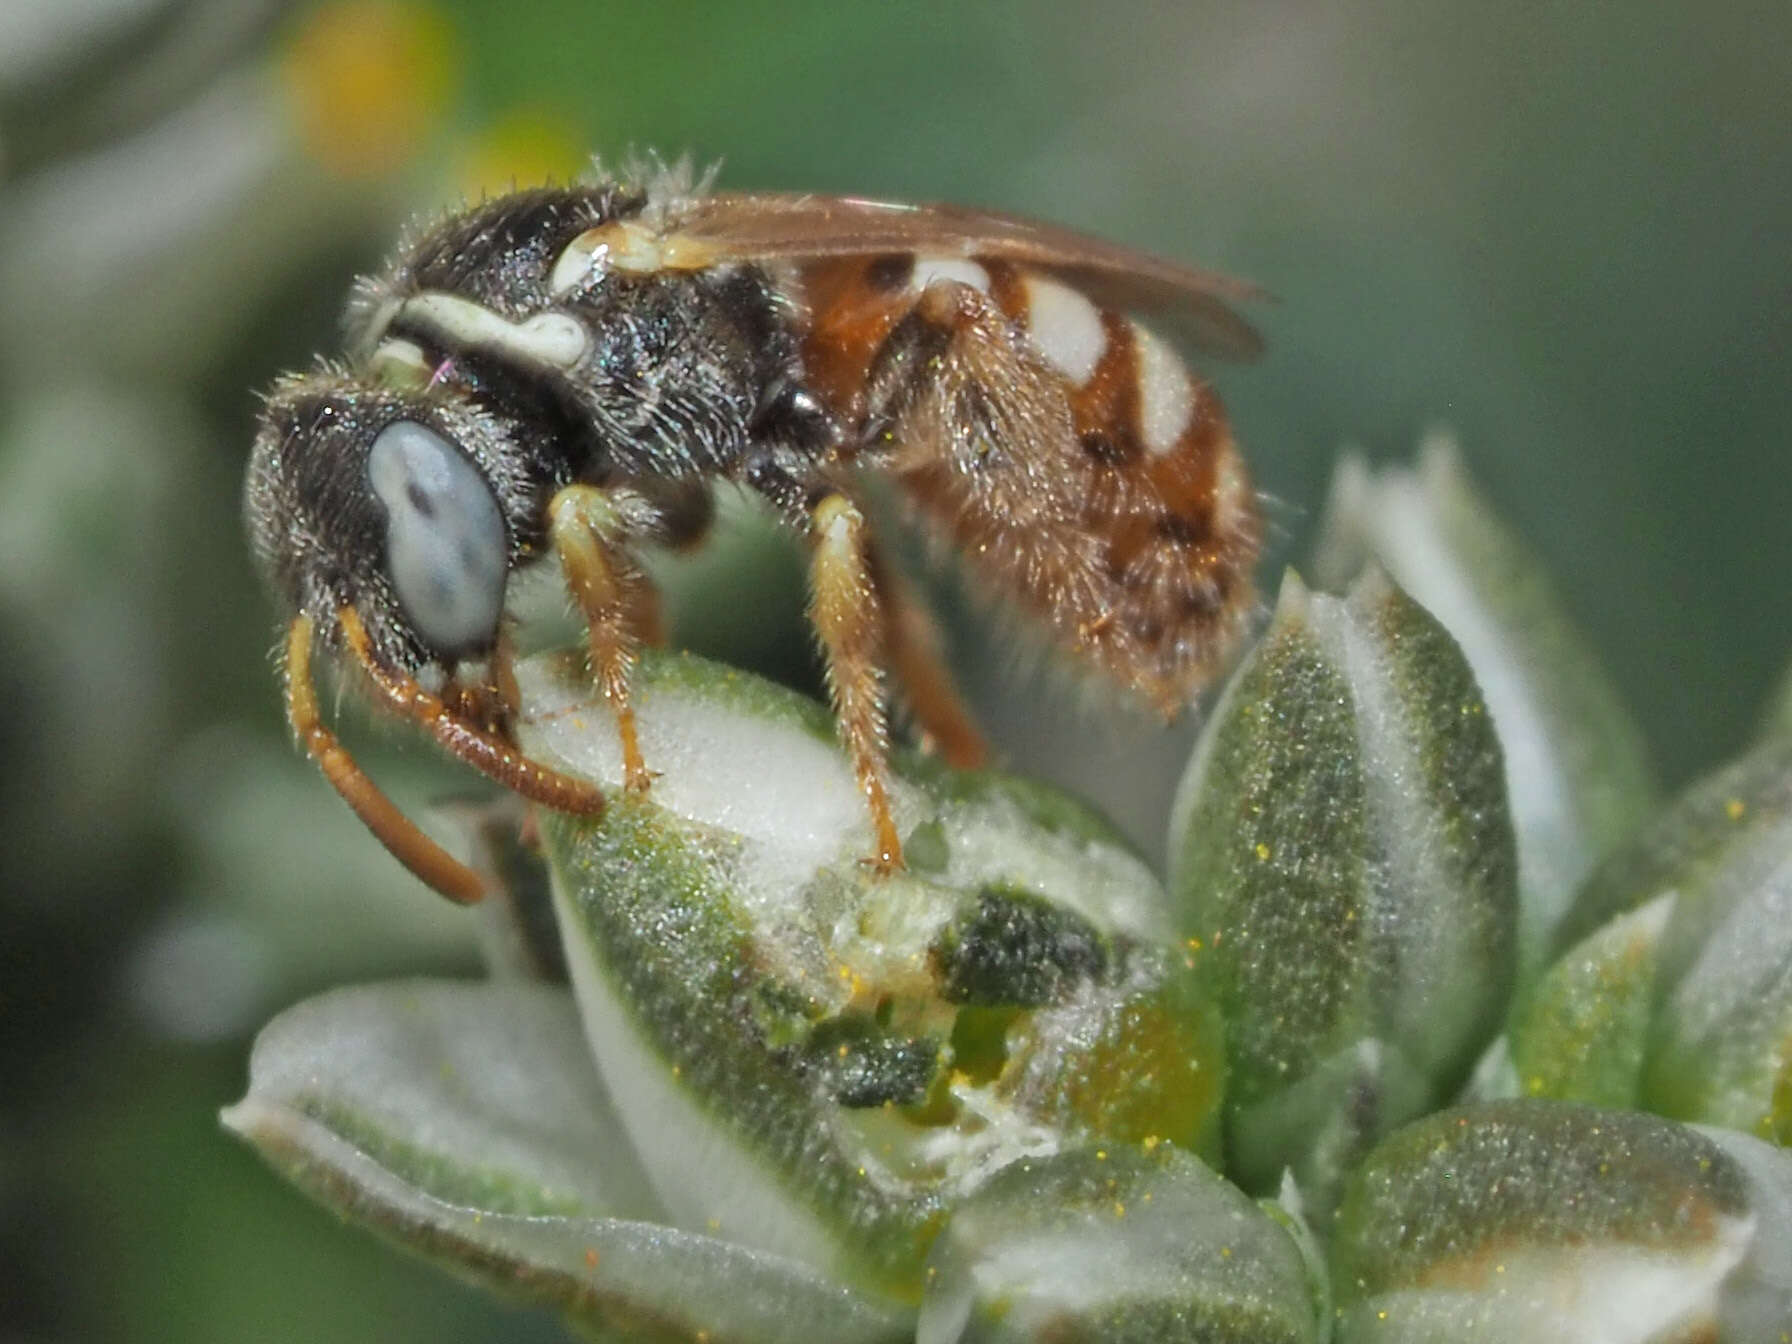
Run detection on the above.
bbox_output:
[246,168,1262,901]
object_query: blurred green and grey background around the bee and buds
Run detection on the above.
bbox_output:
[0,0,1792,1342]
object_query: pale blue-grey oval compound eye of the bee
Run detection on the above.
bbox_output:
[367,419,507,656]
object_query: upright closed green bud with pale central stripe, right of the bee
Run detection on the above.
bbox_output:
[1170,570,1516,1208]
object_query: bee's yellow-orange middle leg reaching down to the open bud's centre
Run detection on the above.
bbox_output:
[808,495,903,873]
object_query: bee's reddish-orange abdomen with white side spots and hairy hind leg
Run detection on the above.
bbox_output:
[808,253,1260,710]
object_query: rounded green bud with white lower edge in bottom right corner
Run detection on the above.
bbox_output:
[1331,1100,1792,1344]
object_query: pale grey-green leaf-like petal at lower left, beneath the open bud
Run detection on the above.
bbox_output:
[224,980,912,1344]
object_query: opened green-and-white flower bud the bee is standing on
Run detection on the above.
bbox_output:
[520,658,1224,1296]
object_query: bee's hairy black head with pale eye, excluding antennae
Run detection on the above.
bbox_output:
[246,375,539,674]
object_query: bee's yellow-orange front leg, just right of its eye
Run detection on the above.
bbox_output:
[548,486,658,794]
